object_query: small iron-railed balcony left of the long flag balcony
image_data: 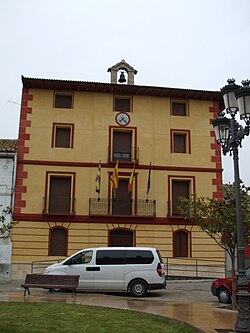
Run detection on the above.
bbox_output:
[43,194,75,215]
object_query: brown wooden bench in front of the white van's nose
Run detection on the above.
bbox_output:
[21,274,80,296]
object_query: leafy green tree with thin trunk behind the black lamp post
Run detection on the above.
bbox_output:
[178,183,250,309]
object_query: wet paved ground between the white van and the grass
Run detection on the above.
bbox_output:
[0,280,237,333]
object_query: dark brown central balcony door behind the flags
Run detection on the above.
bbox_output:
[112,178,132,215]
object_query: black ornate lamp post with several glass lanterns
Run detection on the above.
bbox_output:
[213,79,250,332]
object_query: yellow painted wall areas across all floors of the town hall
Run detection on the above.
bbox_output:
[13,85,224,270]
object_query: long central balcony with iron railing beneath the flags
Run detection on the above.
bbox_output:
[89,198,156,217]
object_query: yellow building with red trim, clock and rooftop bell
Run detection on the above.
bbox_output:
[12,60,224,277]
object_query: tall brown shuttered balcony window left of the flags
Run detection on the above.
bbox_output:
[48,175,73,214]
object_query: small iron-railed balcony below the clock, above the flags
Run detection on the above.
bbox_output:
[108,146,139,163]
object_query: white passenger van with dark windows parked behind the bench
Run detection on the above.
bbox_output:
[44,247,166,297]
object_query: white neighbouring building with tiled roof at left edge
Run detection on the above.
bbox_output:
[0,139,17,280]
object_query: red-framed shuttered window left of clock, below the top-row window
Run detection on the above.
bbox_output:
[52,123,74,148]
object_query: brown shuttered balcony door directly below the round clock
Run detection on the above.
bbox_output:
[112,131,132,161]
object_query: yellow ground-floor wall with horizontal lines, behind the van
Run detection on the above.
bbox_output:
[13,222,224,263]
